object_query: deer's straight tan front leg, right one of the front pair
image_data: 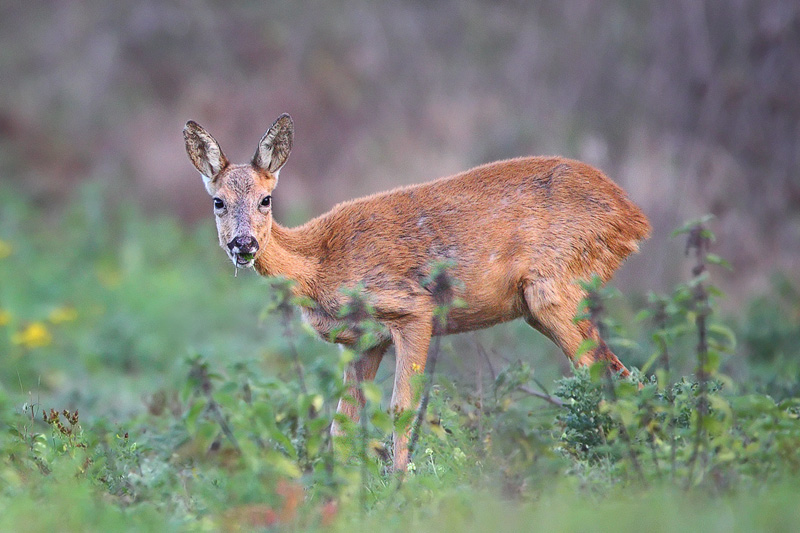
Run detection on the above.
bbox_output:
[391,317,433,472]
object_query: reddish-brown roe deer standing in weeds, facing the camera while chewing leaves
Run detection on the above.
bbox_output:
[183,114,650,470]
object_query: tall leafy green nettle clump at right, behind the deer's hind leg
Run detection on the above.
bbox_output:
[556,217,800,490]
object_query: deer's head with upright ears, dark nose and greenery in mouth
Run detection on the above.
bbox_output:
[183,114,294,268]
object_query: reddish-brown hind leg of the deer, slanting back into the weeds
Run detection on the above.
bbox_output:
[523,278,630,377]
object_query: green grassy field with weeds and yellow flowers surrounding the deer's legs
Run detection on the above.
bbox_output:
[0,184,800,531]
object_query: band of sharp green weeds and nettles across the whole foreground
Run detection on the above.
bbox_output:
[7,215,800,527]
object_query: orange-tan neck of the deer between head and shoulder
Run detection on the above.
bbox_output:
[254,222,318,298]
